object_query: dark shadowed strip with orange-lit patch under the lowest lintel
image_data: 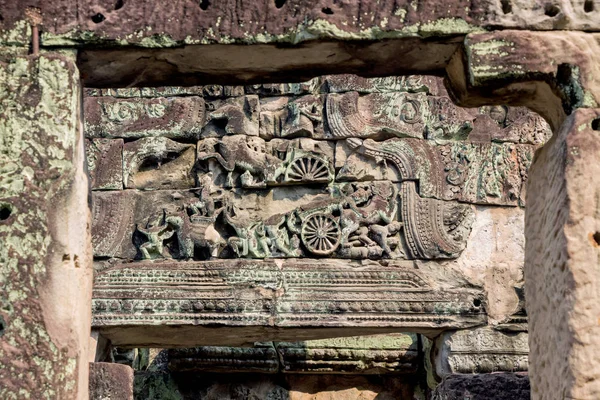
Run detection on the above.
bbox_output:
[135,372,422,400]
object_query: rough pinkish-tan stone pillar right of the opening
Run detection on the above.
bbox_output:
[525,109,600,399]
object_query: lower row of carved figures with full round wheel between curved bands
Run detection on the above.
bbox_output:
[92,180,472,259]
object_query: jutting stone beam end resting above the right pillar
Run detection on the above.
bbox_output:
[446,31,600,131]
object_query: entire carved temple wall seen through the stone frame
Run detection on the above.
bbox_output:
[84,75,551,399]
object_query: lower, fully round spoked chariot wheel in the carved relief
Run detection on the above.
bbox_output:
[300,213,342,256]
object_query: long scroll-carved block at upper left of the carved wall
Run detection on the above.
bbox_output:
[84,96,204,139]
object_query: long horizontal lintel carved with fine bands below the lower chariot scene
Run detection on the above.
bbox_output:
[92,259,485,345]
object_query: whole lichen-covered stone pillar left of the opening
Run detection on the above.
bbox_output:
[0,54,92,399]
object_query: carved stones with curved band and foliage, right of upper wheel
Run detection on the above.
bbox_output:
[336,138,535,205]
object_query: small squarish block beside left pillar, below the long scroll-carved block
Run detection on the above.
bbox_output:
[85,139,123,190]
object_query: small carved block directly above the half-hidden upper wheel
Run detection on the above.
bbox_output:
[260,95,323,139]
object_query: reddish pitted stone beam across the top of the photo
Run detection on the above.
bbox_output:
[0,0,600,48]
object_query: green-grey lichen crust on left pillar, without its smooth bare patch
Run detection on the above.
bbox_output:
[0,55,79,399]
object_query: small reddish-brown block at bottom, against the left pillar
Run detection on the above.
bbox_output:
[90,363,133,400]
